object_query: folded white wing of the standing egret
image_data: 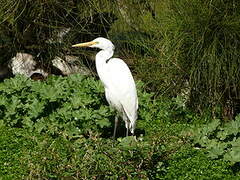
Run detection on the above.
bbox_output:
[107,58,138,121]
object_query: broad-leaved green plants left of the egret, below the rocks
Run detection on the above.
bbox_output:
[0,75,113,137]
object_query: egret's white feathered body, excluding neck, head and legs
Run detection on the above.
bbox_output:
[105,58,138,133]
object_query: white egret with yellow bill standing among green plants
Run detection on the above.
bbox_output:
[72,37,138,137]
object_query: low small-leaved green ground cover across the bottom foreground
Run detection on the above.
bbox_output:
[0,119,236,179]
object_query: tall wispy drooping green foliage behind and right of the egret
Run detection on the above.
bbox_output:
[112,0,240,115]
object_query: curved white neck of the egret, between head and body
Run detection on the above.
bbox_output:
[96,48,114,85]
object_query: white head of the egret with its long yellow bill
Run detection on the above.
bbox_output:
[72,37,114,50]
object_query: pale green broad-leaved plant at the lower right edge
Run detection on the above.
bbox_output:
[193,116,240,164]
